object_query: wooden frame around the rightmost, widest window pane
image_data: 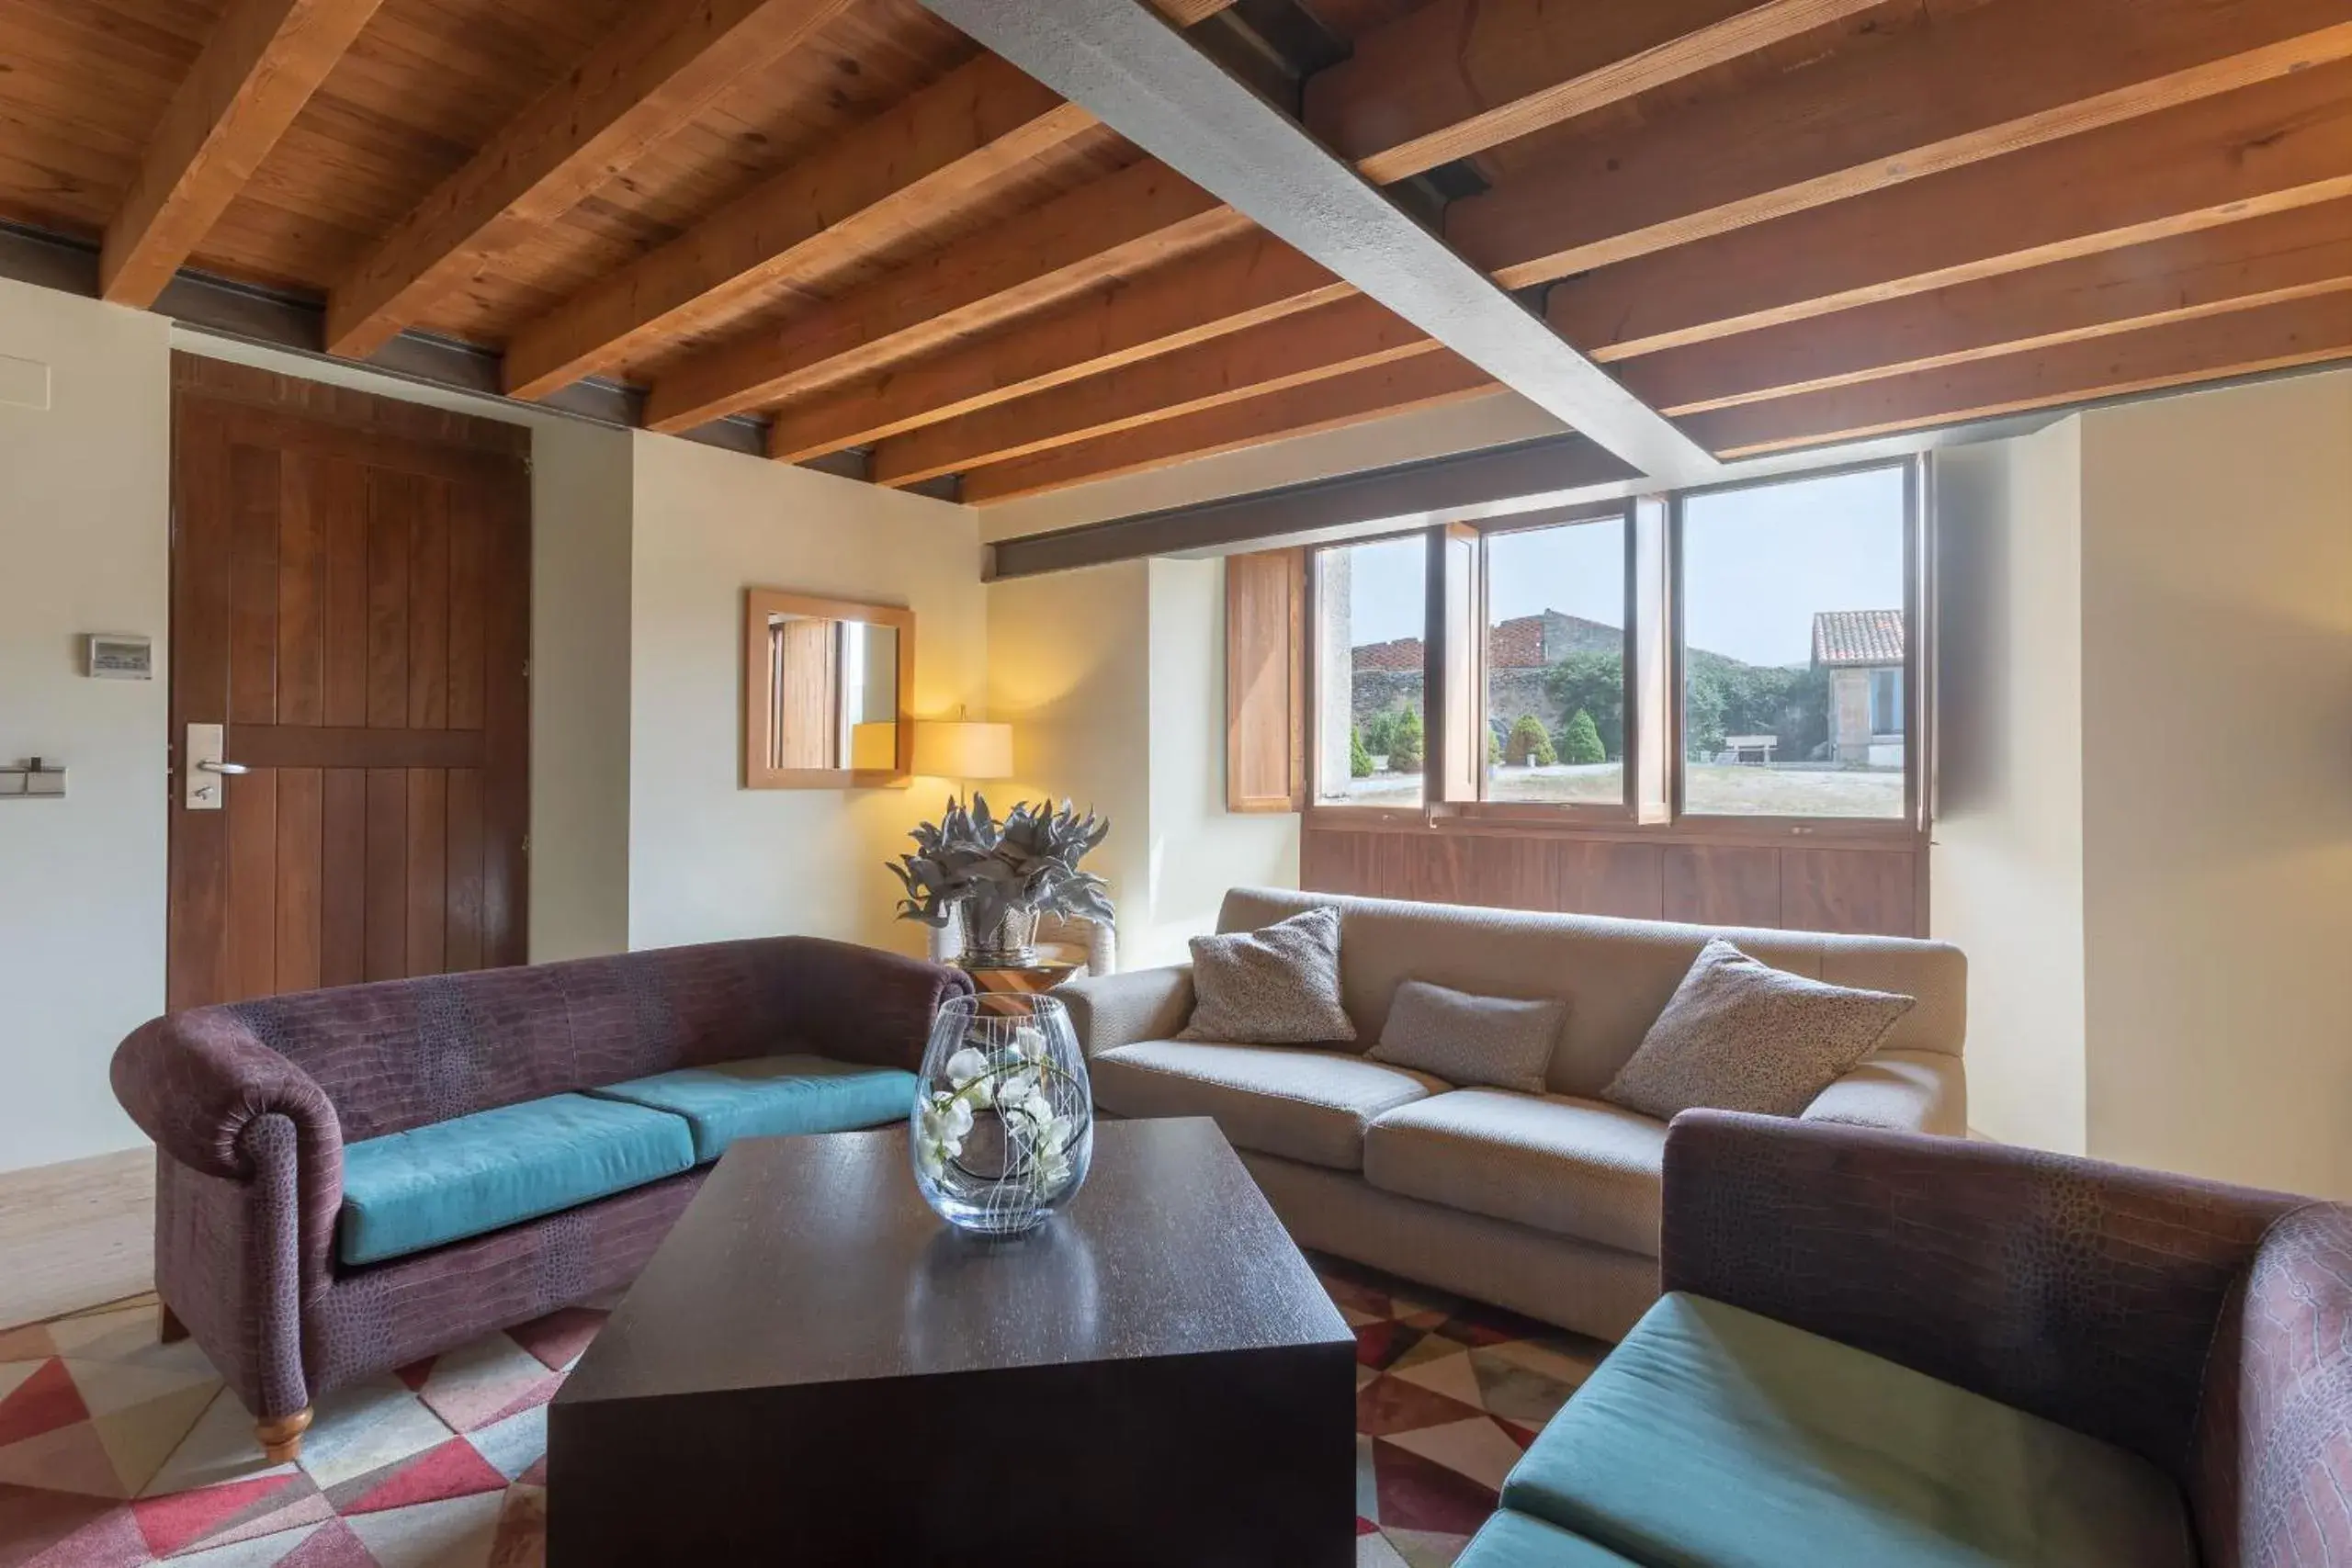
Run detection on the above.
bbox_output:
[1665,456,1933,846]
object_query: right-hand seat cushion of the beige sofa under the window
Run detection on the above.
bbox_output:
[1364,1089,1665,1258]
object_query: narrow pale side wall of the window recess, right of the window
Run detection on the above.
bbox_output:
[1928,419,2086,1155]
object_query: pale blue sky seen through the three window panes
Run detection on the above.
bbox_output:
[1348,468,1903,665]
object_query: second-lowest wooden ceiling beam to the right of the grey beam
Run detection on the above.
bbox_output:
[1618,202,2352,419]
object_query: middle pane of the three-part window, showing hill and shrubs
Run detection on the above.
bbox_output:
[1487,520,1625,807]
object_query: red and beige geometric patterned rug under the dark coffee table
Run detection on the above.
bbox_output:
[0,1258,1606,1568]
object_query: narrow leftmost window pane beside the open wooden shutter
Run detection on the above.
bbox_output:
[1315,534,1430,807]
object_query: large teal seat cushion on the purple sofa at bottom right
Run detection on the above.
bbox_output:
[1503,1295,2197,1568]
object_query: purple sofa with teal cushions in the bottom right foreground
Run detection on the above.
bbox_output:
[1461,1112,2352,1568]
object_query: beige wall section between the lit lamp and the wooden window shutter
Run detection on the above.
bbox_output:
[988,559,1298,968]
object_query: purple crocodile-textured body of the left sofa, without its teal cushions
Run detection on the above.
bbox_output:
[113,936,971,1458]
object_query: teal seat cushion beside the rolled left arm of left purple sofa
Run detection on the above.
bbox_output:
[336,1096,694,1262]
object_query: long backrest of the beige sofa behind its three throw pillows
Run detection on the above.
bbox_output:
[1218,888,1969,1098]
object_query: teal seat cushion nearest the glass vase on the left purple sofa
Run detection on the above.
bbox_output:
[588,1055,915,1164]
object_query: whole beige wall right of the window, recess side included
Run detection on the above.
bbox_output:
[1933,374,2352,1199]
